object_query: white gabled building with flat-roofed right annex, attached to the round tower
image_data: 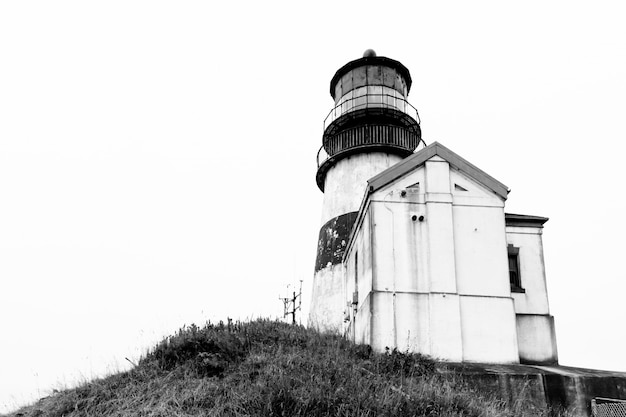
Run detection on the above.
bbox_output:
[343,143,557,363]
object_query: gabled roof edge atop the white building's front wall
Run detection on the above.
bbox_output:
[367,142,509,200]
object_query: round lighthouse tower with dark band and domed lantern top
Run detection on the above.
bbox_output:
[309,49,421,331]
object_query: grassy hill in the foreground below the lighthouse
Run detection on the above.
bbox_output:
[4,320,564,417]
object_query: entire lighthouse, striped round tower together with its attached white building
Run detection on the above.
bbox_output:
[309,50,557,364]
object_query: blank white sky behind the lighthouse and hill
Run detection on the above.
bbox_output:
[0,0,626,412]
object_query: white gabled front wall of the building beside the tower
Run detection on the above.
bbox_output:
[345,156,519,363]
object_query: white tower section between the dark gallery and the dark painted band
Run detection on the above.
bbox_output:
[321,152,402,224]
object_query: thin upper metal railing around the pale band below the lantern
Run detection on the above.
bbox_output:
[324,93,420,131]
